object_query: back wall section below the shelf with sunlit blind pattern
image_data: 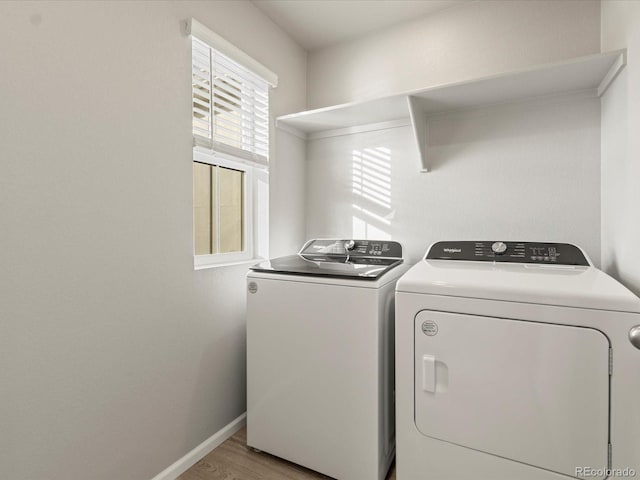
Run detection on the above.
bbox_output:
[307,95,600,264]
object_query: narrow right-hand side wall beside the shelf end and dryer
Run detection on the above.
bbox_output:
[602,0,640,295]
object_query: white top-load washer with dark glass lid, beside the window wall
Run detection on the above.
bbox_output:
[247,239,407,480]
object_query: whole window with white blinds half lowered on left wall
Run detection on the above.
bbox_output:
[190,20,277,266]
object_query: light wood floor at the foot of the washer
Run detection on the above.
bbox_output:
[178,428,396,480]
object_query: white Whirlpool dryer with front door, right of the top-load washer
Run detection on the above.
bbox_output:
[396,242,640,480]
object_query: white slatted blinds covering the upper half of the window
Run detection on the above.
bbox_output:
[192,31,269,165]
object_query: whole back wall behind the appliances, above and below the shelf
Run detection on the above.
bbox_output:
[307,0,600,264]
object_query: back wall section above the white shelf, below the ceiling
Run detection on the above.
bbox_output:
[307,0,600,108]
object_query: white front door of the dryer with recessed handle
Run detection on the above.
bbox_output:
[414,310,609,478]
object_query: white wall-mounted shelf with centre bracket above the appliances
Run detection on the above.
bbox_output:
[277,50,626,172]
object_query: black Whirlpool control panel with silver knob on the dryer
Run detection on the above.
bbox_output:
[425,241,590,266]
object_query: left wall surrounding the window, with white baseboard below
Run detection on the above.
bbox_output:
[0,1,306,480]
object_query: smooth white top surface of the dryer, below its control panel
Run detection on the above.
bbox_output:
[396,260,640,313]
